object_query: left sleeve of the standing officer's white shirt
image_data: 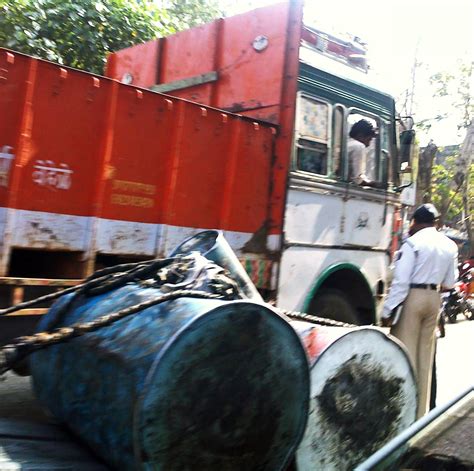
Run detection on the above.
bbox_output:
[382,242,416,318]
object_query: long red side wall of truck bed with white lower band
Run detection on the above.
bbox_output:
[0,49,275,275]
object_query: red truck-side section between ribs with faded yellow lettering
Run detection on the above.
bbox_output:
[98,84,177,223]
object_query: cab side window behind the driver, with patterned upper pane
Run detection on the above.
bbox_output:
[296,95,331,175]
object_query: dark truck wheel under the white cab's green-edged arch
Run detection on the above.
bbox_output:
[311,289,360,324]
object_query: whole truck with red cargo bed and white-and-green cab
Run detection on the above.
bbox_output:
[0,1,415,338]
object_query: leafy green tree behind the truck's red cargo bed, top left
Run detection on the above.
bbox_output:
[0,0,222,74]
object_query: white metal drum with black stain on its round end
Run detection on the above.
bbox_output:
[291,321,417,471]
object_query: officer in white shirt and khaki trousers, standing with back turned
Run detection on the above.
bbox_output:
[382,204,458,418]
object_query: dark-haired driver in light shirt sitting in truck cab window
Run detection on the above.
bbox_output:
[347,119,382,188]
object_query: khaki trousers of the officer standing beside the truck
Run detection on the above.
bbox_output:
[390,288,440,418]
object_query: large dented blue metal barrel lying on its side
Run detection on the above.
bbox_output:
[30,283,309,471]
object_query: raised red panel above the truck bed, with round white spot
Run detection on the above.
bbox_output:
[107,3,292,124]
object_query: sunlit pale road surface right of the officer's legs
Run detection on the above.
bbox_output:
[436,316,474,405]
